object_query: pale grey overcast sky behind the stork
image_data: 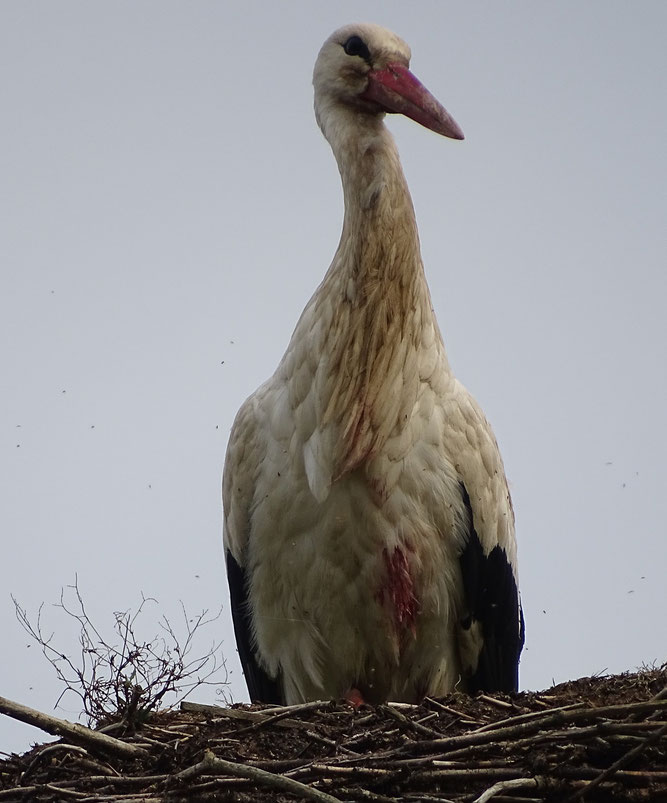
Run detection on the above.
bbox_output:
[0,0,667,751]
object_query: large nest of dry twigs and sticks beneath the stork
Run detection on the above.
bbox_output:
[0,665,667,803]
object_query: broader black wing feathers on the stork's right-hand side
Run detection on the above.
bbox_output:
[460,483,524,693]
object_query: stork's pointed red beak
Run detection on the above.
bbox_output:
[361,63,463,139]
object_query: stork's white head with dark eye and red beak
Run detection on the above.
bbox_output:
[313,23,463,139]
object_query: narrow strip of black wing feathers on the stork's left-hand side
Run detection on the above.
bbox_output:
[225,550,285,705]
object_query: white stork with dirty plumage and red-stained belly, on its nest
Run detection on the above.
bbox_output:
[223,24,523,704]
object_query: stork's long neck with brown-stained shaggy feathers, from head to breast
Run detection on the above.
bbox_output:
[315,112,446,476]
